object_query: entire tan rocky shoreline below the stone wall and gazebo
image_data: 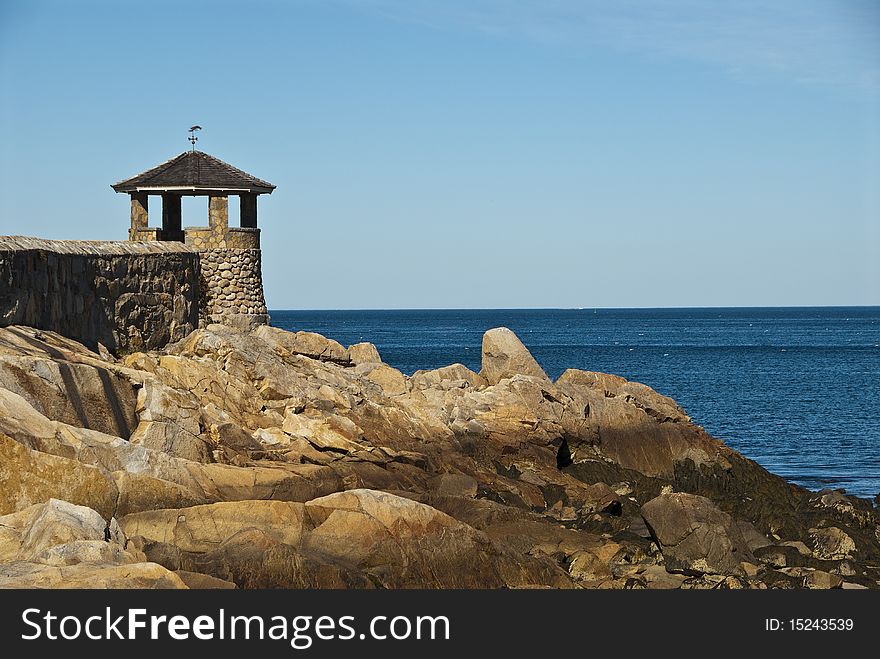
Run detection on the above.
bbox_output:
[0,325,880,589]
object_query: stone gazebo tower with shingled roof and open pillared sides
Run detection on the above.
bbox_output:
[112,150,275,326]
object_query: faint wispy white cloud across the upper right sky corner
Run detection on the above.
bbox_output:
[341,0,880,90]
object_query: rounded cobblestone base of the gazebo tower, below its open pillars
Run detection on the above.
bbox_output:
[200,249,269,326]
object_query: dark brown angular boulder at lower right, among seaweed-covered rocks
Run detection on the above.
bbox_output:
[642,493,754,576]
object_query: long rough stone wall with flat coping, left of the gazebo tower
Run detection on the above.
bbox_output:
[0,236,199,352]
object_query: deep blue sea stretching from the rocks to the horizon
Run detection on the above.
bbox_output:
[270,307,880,498]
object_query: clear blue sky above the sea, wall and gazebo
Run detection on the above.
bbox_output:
[0,0,880,309]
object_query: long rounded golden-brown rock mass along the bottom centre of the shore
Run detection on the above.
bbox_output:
[121,490,565,587]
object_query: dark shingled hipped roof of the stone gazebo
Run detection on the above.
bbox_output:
[110,151,275,194]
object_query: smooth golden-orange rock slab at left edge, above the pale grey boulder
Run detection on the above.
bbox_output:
[0,432,118,518]
